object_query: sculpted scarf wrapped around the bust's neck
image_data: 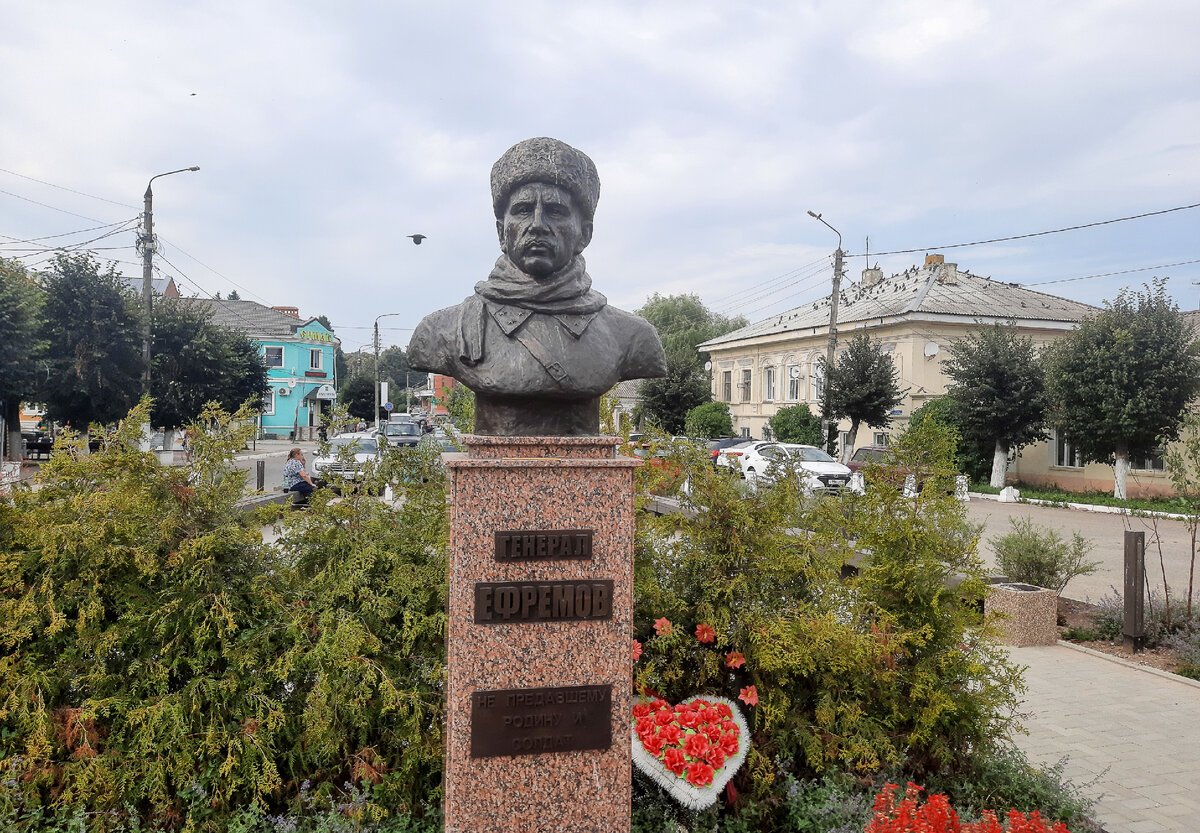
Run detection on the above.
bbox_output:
[458,254,608,365]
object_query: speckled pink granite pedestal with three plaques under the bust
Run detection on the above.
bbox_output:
[445,436,641,833]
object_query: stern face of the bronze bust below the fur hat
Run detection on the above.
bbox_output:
[496,182,592,278]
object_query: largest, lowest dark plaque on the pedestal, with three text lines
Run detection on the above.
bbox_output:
[470,685,612,757]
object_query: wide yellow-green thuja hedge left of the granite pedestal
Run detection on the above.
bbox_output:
[0,402,446,831]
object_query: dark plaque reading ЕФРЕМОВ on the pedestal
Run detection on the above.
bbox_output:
[475,579,612,624]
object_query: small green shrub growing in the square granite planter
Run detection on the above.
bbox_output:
[991,516,1100,594]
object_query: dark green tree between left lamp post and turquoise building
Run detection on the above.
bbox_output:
[150,299,266,430]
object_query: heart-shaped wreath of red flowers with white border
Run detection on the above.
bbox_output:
[634,696,750,810]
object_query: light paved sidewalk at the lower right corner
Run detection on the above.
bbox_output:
[1009,645,1200,833]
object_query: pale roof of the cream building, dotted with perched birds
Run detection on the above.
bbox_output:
[700,261,1097,349]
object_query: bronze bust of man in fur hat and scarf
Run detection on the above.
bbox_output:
[408,138,666,437]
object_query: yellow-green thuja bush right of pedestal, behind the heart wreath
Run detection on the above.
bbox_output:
[635,424,1022,829]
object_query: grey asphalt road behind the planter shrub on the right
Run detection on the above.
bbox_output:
[967,498,1200,601]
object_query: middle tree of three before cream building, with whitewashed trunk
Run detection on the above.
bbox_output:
[942,322,1046,489]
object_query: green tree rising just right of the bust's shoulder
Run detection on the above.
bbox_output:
[637,293,746,433]
